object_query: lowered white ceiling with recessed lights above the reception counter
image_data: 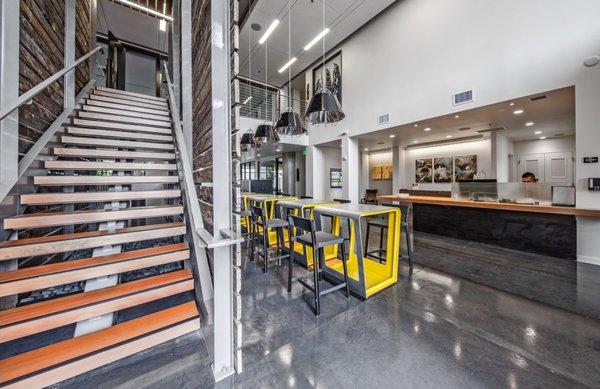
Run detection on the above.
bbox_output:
[359,87,575,151]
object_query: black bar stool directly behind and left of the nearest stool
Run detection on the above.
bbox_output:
[250,205,290,273]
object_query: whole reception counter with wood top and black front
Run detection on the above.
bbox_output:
[378,195,600,259]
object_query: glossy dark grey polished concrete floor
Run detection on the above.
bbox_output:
[58,236,600,388]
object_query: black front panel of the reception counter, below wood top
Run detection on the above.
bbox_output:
[413,203,577,259]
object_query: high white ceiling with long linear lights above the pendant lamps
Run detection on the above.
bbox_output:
[239,0,395,87]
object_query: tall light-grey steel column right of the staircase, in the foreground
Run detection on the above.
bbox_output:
[211,1,235,381]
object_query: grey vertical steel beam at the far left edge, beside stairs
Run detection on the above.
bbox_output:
[0,1,20,189]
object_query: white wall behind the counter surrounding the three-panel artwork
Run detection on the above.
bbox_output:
[400,139,495,191]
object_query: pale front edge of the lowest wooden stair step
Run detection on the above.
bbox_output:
[7,319,200,389]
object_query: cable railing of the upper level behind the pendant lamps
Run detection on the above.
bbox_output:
[239,82,307,122]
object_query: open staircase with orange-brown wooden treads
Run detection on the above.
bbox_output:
[0,87,200,388]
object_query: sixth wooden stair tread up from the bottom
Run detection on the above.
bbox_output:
[21,189,181,205]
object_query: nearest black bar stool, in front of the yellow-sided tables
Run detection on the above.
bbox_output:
[288,215,350,316]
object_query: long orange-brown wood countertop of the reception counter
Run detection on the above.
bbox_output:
[377,195,600,217]
